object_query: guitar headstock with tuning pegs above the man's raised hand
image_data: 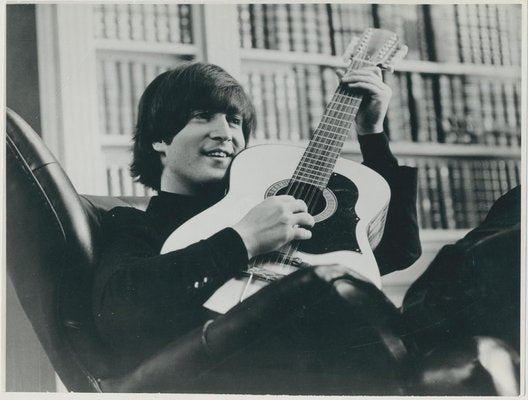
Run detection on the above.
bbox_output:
[343,28,408,72]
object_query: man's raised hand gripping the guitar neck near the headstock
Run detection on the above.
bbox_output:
[336,66,392,135]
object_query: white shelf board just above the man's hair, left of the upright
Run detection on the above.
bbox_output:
[95,39,198,56]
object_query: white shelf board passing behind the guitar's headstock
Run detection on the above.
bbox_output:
[240,49,521,79]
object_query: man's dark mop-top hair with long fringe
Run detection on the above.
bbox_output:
[130,63,256,190]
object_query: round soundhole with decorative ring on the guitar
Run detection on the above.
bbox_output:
[265,179,337,222]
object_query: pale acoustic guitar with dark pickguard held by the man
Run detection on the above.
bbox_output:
[161,29,407,313]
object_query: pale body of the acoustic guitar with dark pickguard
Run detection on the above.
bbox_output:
[161,145,390,312]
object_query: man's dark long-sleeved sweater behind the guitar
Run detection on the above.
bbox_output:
[93,134,420,366]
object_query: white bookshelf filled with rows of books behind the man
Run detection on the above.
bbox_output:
[39,3,521,238]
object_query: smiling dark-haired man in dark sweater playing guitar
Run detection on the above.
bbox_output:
[93,63,420,391]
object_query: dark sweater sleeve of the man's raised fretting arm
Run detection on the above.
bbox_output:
[359,133,422,275]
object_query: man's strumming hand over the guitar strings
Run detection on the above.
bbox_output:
[233,196,315,258]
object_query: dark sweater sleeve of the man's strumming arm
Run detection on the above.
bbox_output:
[93,208,247,354]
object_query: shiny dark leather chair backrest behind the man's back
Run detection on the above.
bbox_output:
[6,110,148,392]
